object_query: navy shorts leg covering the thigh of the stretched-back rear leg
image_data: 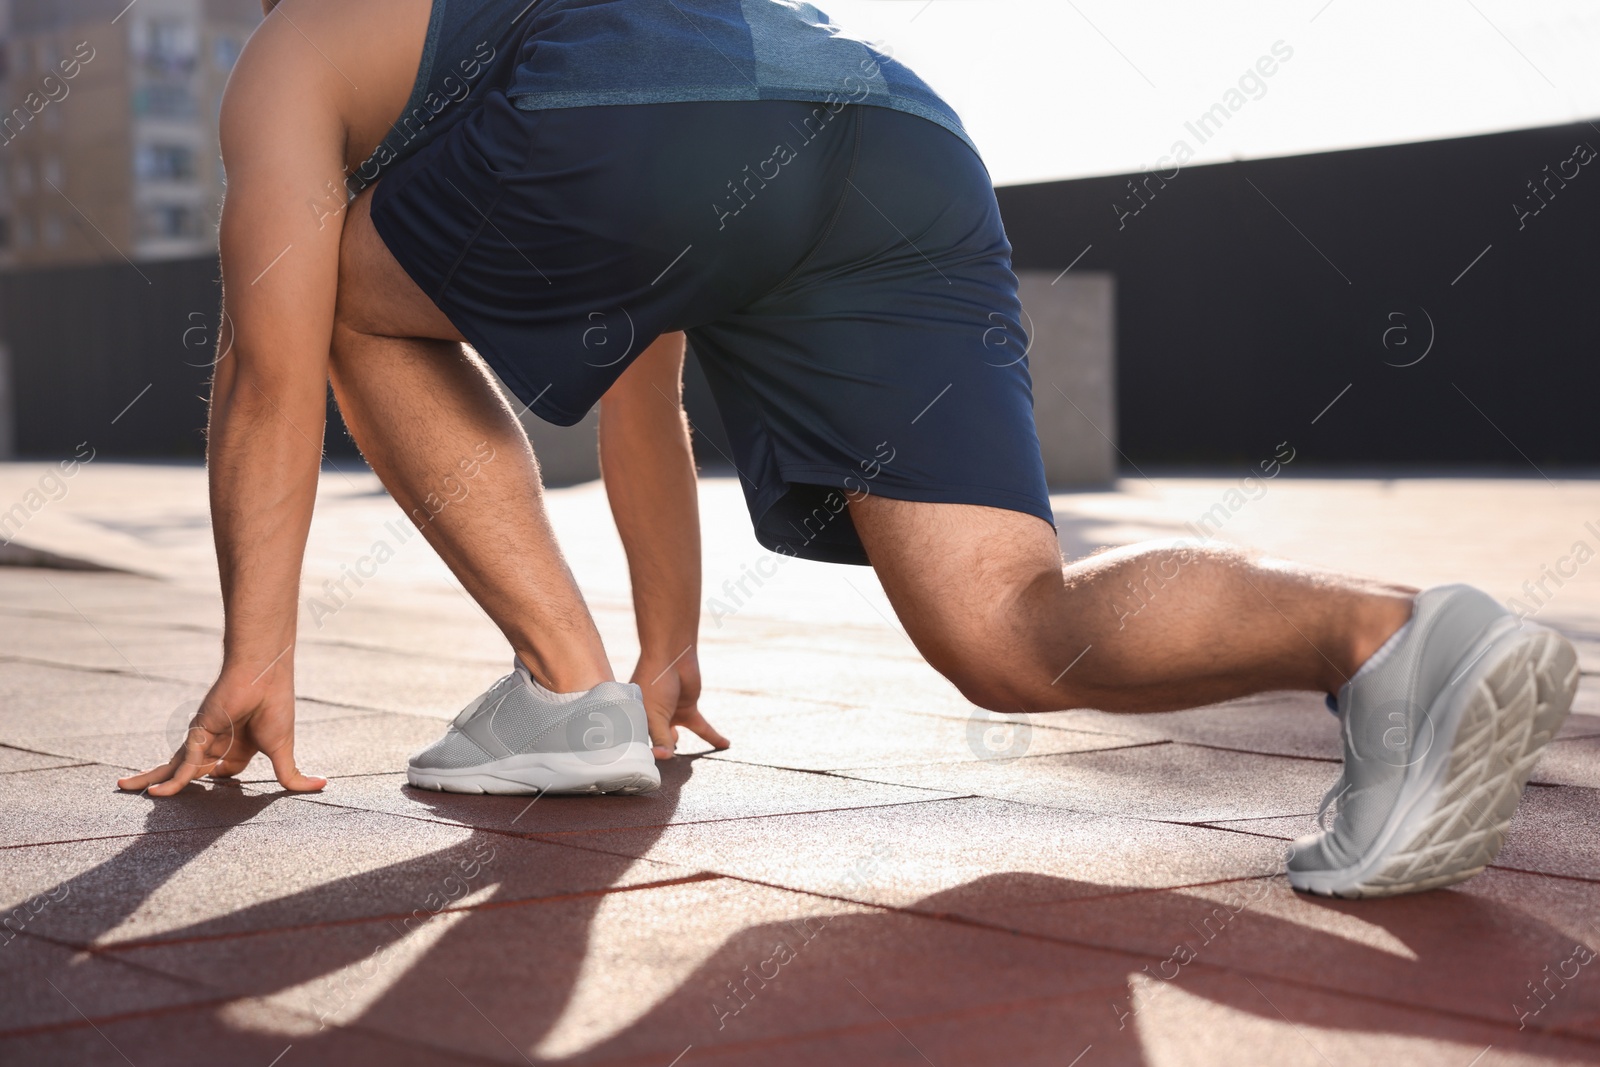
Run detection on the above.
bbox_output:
[690,107,1051,563]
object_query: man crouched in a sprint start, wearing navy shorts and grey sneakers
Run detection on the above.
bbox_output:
[122,0,1578,896]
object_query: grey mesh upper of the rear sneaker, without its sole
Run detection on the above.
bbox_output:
[1290,585,1515,870]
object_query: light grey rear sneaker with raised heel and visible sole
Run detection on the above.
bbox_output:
[1288,585,1578,897]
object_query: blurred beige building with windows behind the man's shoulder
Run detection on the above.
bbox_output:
[0,0,252,269]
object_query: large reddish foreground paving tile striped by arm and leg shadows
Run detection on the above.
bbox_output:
[103,880,1136,1064]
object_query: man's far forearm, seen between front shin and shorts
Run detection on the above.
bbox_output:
[600,334,701,661]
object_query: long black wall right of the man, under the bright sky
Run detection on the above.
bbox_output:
[1000,123,1600,472]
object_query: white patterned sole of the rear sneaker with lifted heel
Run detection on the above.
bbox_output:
[1290,624,1578,897]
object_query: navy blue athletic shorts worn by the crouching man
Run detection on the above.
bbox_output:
[371,91,1053,563]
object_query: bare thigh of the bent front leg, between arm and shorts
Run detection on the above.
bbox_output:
[336,186,462,341]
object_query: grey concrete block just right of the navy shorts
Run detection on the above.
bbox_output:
[1018,270,1117,488]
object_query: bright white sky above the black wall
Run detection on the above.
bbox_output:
[814,0,1600,186]
